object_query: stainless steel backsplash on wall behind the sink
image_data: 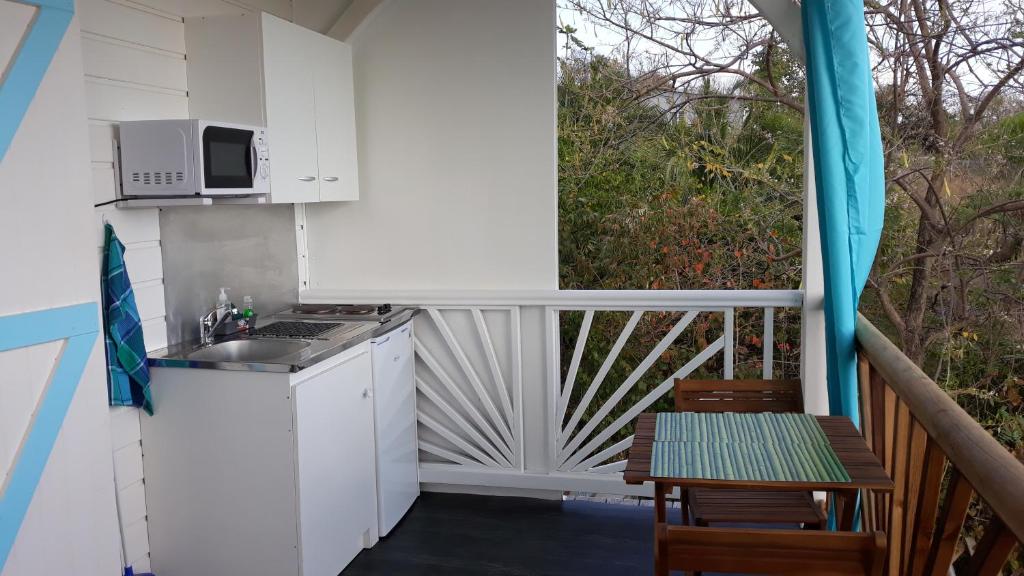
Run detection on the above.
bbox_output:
[160,204,299,344]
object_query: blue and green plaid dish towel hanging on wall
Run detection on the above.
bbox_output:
[99,223,153,416]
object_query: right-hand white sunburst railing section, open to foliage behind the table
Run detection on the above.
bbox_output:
[550,304,790,475]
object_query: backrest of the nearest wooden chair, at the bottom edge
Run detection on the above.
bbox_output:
[657,524,886,576]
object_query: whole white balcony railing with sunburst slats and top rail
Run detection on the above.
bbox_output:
[302,290,803,494]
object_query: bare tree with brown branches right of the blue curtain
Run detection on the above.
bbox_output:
[866,0,1024,362]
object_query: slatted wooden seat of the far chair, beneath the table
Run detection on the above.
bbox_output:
[687,488,825,528]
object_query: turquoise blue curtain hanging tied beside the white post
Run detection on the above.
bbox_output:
[801,0,885,425]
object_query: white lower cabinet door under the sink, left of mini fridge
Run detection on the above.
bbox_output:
[295,352,377,576]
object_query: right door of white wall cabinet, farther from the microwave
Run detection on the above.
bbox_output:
[313,36,359,202]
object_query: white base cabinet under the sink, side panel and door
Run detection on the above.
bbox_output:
[142,343,378,576]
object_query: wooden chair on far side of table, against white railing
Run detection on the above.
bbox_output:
[675,379,825,529]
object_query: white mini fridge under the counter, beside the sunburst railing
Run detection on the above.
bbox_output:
[371,321,420,537]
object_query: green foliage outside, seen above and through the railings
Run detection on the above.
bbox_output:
[558,45,1024,479]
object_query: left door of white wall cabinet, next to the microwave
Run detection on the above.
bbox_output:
[262,13,319,203]
